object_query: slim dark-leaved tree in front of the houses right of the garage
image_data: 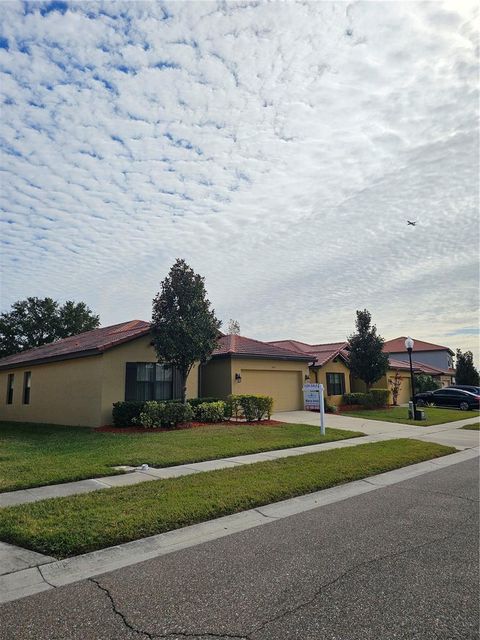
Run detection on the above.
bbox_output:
[348,309,388,391]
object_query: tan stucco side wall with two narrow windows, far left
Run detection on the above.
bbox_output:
[0,355,102,426]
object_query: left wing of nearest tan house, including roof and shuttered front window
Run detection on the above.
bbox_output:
[0,320,198,427]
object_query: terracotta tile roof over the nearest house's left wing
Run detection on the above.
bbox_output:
[0,320,150,369]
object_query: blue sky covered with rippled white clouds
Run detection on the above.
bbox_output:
[0,0,479,363]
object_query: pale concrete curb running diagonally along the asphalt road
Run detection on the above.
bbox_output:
[0,447,480,603]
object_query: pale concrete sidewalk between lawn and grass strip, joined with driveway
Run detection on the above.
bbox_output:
[0,411,480,507]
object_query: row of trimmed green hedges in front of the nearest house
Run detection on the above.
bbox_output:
[112,395,273,427]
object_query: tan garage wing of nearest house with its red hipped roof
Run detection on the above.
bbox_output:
[200,334,312,411]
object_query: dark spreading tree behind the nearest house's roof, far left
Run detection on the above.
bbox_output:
[0,297,100,358]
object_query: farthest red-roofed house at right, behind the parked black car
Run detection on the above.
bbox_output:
[383,336,455,387]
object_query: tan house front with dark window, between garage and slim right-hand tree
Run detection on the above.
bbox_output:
[269,340,350,405]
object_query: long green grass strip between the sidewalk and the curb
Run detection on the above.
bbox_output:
[0,439,455,558]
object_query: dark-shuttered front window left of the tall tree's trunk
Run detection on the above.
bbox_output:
[125,362,182,401]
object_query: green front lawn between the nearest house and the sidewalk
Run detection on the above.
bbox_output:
[0,423,364,492]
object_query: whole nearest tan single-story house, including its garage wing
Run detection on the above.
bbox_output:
[0,320,310,427]
